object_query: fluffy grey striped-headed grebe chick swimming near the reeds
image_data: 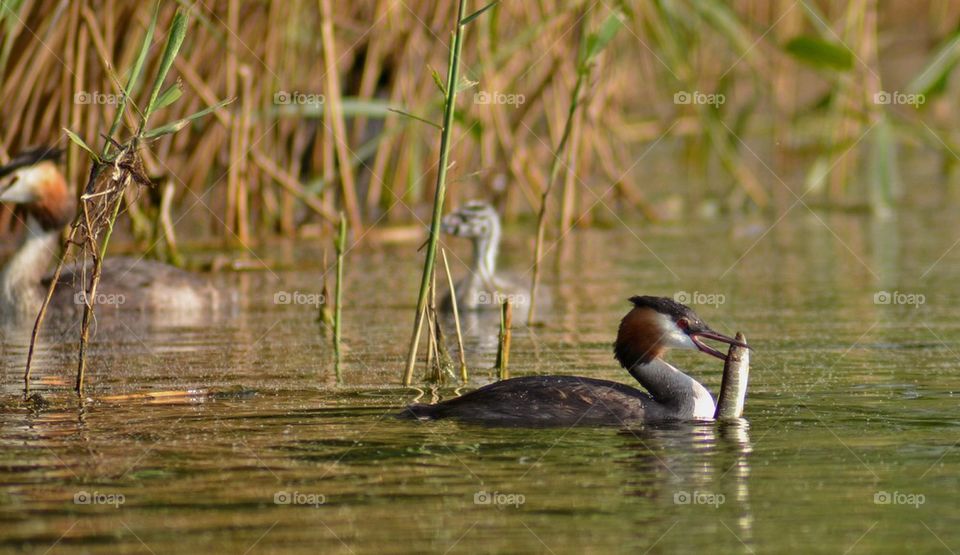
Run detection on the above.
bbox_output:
[440,200,530,310]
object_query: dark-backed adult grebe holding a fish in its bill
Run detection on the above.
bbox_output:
[400,296,749,426]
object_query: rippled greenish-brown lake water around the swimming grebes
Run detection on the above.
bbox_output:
[0,209,960,553]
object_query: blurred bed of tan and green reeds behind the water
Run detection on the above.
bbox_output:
[0,0,960,247]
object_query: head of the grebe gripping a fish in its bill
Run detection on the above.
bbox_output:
[613,296,749,369]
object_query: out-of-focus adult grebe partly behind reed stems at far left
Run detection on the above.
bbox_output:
[0,148,220,327]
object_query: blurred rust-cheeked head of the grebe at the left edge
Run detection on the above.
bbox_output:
[0,147,73,229]
